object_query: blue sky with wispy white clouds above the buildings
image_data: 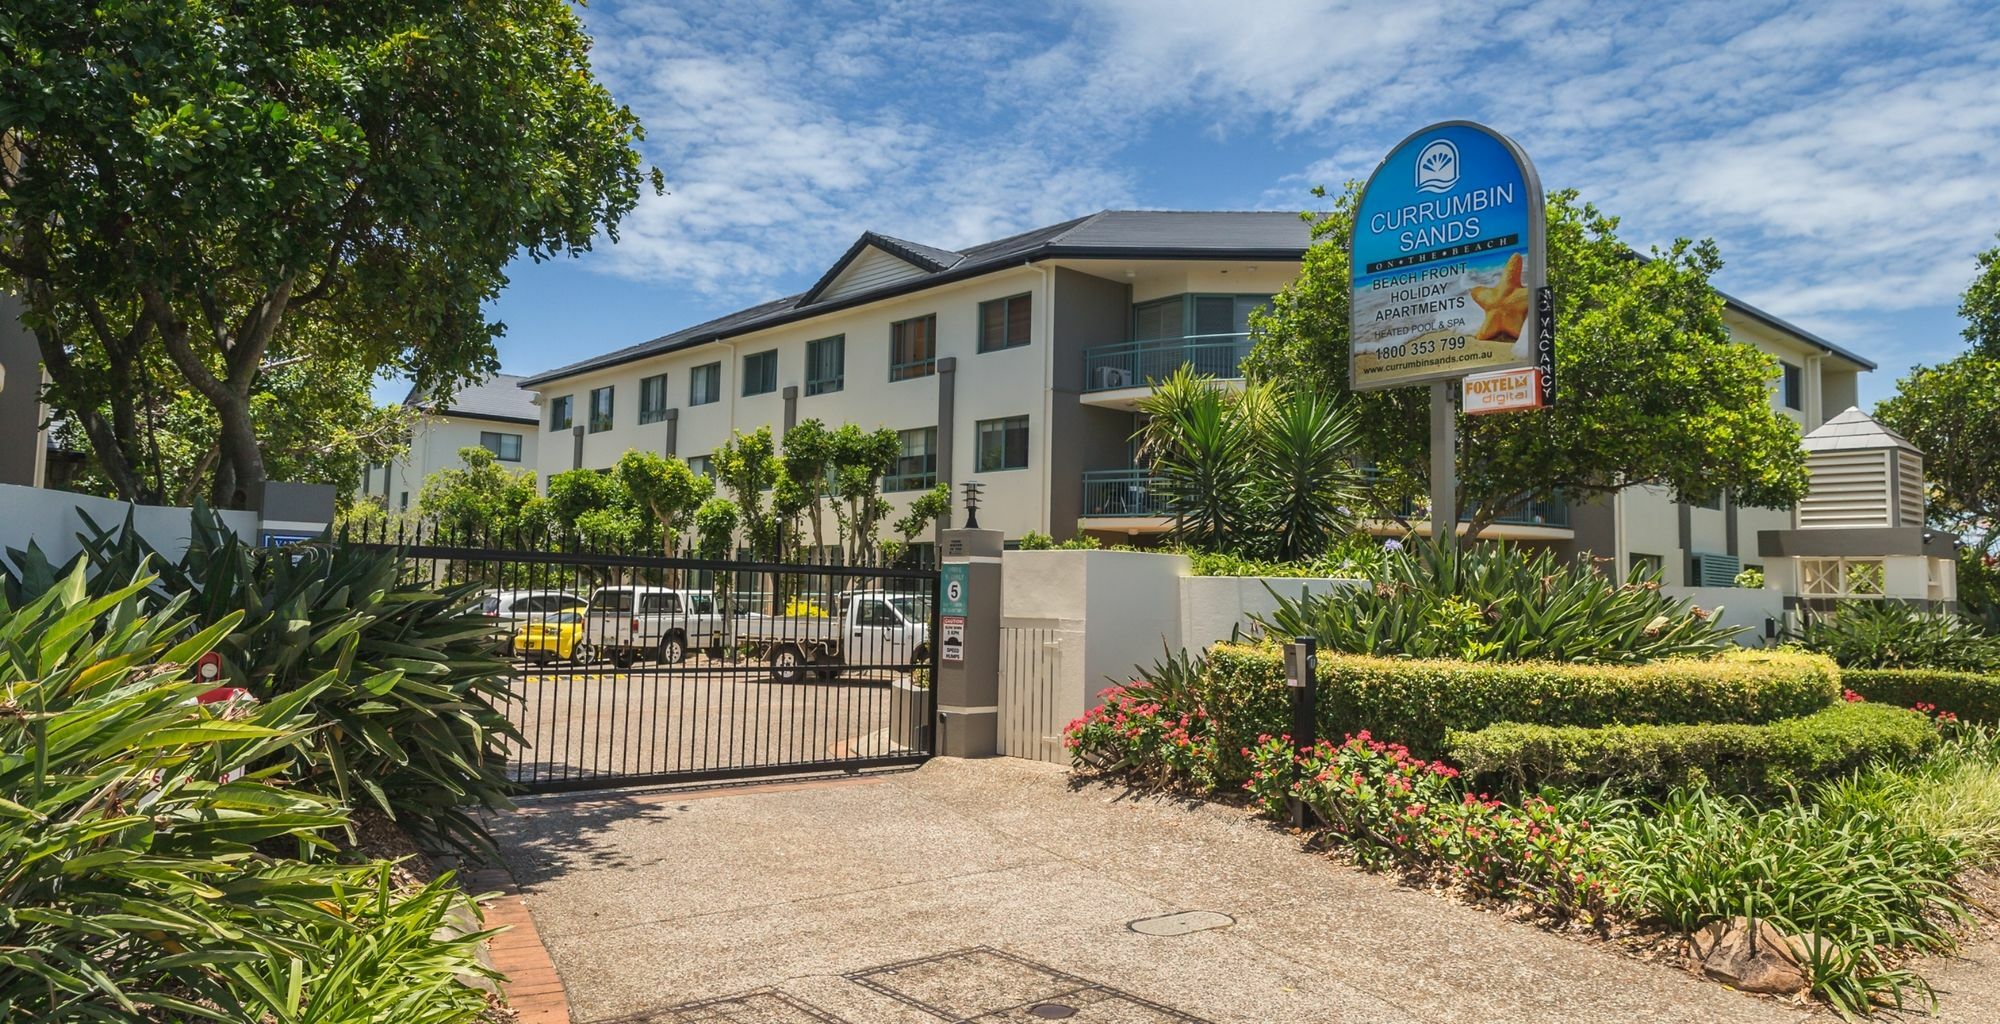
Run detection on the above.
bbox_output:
[438,0,2000,404]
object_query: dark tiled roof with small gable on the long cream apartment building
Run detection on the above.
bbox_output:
[522,210,1876,388]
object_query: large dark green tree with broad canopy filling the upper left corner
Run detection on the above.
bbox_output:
[0,0,660,506]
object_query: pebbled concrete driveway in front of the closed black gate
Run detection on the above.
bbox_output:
[498,758,2000,1024]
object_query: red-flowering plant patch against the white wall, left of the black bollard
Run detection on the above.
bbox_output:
[1062,686,1216,790]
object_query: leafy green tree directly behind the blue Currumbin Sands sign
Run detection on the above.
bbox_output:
[1246,184,1806,532]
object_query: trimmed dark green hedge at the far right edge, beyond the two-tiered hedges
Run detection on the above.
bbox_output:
[1800,600,2000,672]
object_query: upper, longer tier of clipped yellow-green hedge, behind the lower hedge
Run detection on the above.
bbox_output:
[1202,644,1840,774]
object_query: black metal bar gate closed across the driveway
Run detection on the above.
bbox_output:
[346,526,938,792]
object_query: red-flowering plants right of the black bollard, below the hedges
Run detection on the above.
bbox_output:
[1244,732,1614,920]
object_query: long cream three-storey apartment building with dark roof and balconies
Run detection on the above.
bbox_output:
[522,210,1948,608]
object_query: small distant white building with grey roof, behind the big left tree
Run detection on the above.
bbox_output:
[360,374,542,512]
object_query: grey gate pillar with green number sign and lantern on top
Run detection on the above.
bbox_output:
[936,530,1002,758]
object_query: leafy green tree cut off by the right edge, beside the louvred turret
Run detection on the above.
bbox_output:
[1876,236,2000,554]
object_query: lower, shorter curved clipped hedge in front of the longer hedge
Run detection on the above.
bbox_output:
[1446,702,1938,796]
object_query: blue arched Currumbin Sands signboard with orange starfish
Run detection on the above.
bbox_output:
[1348,120,1554,390]
